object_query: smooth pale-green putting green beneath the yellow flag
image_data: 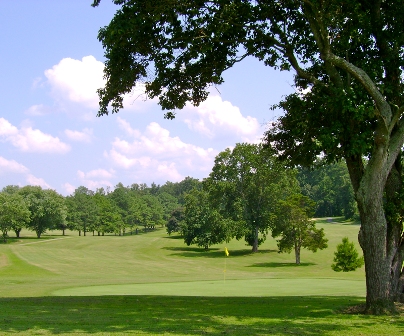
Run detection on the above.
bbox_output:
[52,278,365,297]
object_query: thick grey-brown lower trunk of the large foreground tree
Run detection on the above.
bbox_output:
[347,157,403,315]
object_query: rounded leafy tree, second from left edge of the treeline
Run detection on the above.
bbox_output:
[19,186,66,238]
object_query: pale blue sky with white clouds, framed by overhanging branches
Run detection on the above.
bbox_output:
[0,0,294,195]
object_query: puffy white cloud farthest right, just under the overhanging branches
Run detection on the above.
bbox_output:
[178,95,262,142]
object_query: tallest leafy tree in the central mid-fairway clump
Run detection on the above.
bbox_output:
[204,143,297,252]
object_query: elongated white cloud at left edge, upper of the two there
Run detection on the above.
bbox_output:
[0,118,70,154]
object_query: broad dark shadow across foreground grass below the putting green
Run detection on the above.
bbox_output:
[0,296,404,336]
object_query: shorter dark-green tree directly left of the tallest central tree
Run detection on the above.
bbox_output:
[181,189,232,250]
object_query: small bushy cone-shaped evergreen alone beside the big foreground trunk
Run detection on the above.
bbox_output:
[331,237,364,272]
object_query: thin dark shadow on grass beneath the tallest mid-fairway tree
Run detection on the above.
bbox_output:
[163,247,277,258]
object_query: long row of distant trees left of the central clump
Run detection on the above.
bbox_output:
[0,177,200,241]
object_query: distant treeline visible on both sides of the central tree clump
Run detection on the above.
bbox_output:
[0,158,355,241]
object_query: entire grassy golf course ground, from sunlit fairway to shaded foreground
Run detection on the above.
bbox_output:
[0,219,404,335]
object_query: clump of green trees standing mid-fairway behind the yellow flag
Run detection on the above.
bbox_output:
[167,143,327,264]
